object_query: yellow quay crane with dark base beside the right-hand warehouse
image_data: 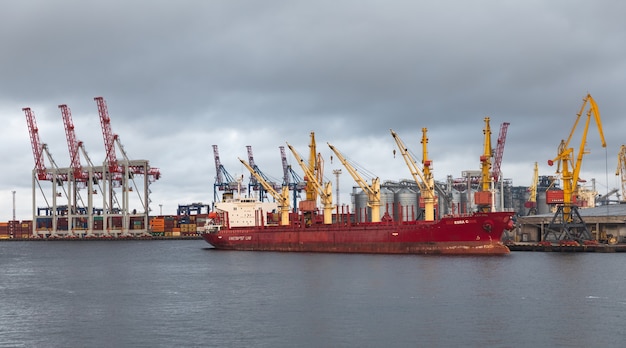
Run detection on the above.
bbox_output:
[544,94,606,241]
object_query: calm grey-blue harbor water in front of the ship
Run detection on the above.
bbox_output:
[0,240,626,348]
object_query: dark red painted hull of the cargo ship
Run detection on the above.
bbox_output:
[202,212,513,255]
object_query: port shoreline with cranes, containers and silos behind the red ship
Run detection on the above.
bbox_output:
[0,95,626,251]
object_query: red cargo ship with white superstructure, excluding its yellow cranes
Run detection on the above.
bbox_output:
[201,199,514,255]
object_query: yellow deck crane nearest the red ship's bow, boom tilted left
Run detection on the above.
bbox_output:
[390,128,435,221]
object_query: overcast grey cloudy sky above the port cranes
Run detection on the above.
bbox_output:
[0,0,626,221]
